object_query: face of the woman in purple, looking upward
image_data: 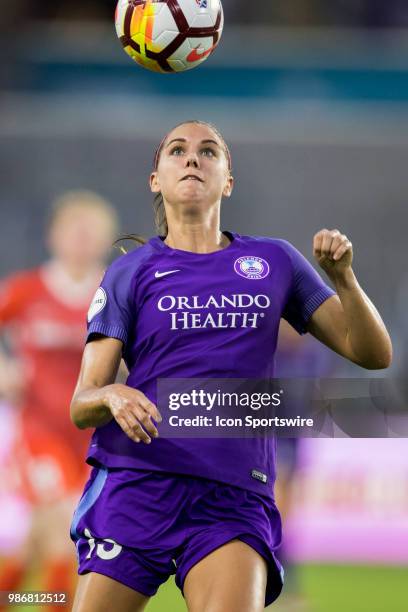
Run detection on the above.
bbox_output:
[150,123,233,207]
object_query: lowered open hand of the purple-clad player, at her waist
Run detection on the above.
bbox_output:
[106,384,162,444]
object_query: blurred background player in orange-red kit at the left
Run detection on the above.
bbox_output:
[0,191,117,608]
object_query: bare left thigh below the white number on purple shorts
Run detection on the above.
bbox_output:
[72,572,150,612]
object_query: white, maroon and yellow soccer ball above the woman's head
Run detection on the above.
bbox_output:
[115,0,224,72]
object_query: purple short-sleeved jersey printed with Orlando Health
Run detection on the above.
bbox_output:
[84,232,334,496]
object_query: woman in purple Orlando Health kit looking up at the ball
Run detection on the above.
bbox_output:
[71,121,392,612]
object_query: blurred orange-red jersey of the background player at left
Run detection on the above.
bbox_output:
[0,265,99,456]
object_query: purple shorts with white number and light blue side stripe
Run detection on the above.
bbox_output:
[71,466,283,605]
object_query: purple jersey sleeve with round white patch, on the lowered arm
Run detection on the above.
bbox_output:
[86,256,134,344]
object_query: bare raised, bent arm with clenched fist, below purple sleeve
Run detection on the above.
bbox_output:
[308,229,392,370]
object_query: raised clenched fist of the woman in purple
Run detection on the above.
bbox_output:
[313,229,353,276]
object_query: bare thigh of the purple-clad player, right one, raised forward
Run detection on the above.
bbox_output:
[183,540,268,612]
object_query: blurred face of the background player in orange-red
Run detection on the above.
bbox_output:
[48,202,115,267]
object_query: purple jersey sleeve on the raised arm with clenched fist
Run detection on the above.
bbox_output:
[281,241,335,334]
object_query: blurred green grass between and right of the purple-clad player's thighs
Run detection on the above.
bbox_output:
[146,565,408,612]
